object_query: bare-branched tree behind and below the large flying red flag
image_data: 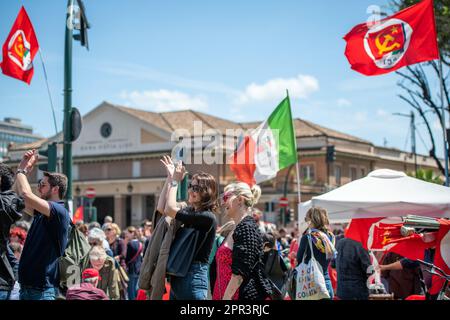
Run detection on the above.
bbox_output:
[391,0,450,174]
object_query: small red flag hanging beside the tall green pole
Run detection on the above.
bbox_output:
[0,6,39,84]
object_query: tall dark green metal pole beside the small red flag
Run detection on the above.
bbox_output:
[63,0,73,209]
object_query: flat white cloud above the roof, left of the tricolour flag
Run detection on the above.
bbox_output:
[119,89,208,112]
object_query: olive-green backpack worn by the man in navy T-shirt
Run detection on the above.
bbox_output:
[58,221,91,293]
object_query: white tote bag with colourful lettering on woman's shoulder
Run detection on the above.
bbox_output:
[295,235,330,300]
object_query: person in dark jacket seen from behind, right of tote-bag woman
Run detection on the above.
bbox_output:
[332,238,373,300]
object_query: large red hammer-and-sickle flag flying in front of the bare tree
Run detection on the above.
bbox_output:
[344,0,439,76]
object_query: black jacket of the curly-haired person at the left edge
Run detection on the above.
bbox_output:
[0,191,25,290]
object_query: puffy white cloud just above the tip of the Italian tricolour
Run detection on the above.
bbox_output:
[238,74,319,104]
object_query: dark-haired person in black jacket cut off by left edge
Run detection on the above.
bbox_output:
[0,163,25,300]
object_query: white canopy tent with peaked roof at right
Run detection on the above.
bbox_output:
[299,169,450,223]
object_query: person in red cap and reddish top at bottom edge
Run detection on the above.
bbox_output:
[66,268,109,300]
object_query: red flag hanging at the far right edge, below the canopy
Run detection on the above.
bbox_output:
[430,219,450,295]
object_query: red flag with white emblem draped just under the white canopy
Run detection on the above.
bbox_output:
[346,218,436,260]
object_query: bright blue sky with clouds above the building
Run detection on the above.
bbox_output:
[0,0,448,157]
